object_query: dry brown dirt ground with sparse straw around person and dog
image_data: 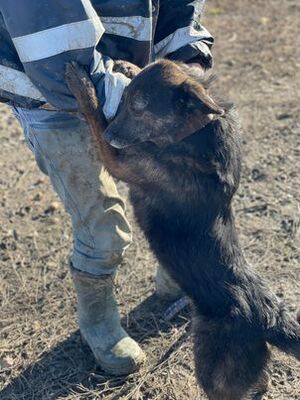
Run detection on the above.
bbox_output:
[0,0,300,400]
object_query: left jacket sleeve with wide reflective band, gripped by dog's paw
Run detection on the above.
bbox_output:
[0,0,129,119]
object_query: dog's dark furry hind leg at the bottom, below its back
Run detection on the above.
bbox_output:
[194,316,269,400]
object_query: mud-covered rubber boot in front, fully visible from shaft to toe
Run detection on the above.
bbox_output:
[71,268,145,375]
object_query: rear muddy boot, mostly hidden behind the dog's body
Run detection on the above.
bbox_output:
[155,265,184,300]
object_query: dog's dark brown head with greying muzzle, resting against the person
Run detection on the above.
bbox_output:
[104,60,224,148]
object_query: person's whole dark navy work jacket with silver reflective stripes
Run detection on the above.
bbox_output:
[0,0,213,118]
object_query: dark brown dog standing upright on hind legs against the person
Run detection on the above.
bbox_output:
[67,61,300,400]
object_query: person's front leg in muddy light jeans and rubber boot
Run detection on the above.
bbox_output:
[15,109,144,375]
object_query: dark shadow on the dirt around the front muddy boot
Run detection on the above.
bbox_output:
[0,295,190,400]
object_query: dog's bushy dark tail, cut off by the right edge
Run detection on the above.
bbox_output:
[265,310,300,360]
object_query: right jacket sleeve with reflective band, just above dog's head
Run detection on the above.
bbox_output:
[154,0,214,68]
